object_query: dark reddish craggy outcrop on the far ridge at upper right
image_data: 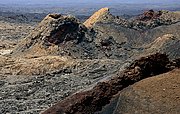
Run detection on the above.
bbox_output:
[129,10,180,30]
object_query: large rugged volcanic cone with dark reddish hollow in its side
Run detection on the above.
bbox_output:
[9,14,133,59]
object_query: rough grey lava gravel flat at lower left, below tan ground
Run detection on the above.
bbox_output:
[0,60,122,114]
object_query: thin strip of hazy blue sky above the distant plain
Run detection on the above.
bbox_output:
[0,0,180,4]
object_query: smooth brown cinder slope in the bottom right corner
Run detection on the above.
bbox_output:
[114,69,180,114]
